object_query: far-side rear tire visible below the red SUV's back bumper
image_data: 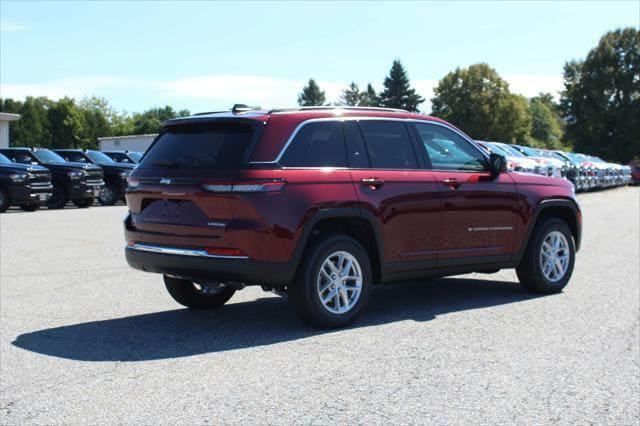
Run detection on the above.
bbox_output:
[164,275,236,309]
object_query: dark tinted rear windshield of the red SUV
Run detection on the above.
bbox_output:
[140,123,253,169]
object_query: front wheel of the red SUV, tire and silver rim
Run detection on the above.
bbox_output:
[516,218,576,294]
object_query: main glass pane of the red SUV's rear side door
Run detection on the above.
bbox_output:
[360,120,418,169]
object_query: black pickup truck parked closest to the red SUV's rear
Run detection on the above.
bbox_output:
[54,149,135,206]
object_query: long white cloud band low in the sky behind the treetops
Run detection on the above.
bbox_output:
[0,74,563,111]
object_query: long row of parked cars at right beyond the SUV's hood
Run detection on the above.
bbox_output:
[477,141,640,191]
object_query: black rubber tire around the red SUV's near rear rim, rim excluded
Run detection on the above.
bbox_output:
[289,235,373,328]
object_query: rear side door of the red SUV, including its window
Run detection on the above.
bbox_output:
[345,119,440,269]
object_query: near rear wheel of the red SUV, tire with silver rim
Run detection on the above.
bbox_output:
[287,235,373,328]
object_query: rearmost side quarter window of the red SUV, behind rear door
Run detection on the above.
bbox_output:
[280,121,347,167]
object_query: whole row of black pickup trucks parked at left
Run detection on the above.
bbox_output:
[0,147,140,212]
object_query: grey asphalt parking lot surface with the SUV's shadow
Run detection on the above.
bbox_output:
[0,187,640,424]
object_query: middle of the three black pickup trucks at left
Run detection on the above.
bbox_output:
[0,148,104,209]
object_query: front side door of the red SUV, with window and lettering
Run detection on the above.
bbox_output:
[413,123,519,266]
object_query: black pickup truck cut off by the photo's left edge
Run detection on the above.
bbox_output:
[0,154,53,213]
